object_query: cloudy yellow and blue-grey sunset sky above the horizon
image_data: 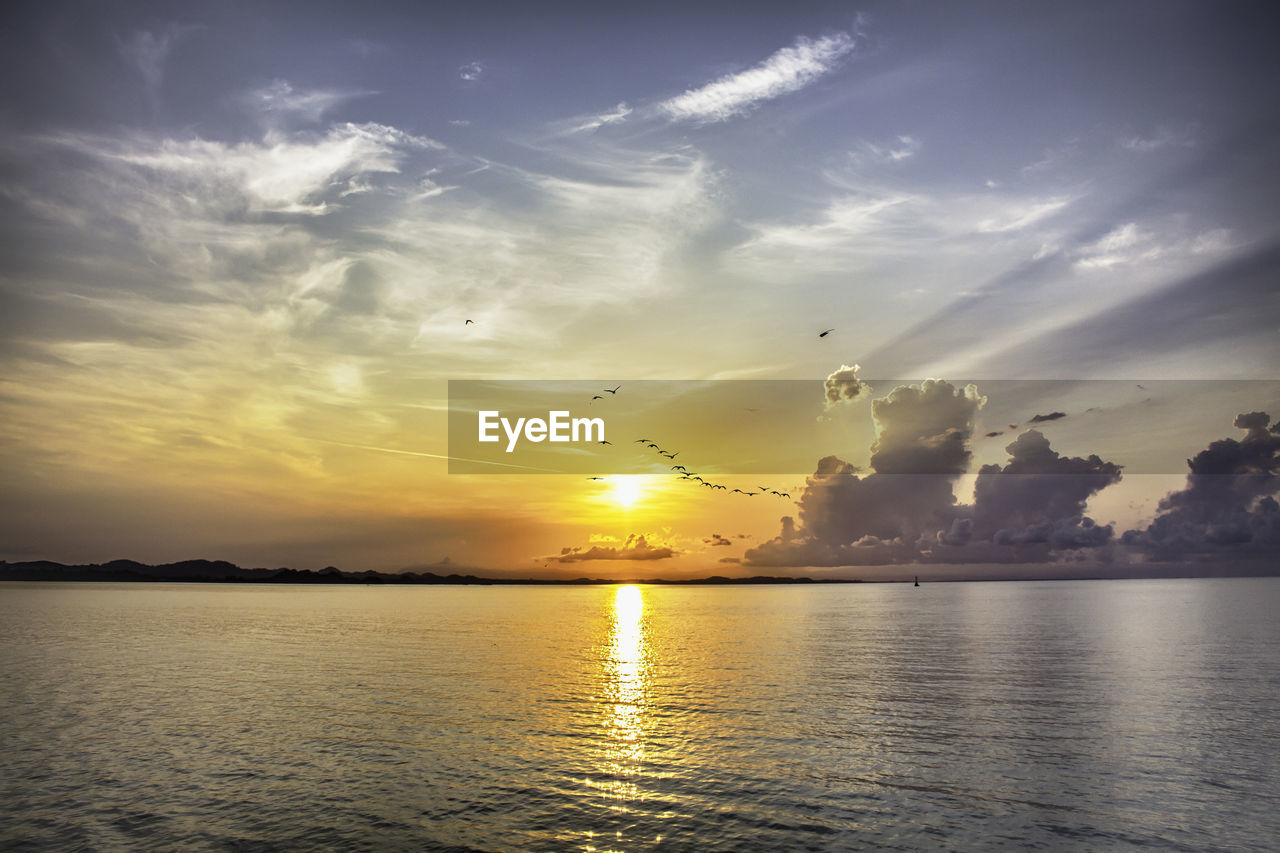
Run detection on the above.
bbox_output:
[0,0,1280,578]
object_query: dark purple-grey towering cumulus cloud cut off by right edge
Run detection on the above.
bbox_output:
[1123,411,1280,560]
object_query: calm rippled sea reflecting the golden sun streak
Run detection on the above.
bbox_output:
[0,579,1280,850]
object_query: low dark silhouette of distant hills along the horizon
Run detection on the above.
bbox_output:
[0,560,859,585]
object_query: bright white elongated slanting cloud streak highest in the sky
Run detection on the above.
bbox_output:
[659,32,856,124]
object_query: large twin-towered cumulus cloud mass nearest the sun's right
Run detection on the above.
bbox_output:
[745,380,1120,566]
